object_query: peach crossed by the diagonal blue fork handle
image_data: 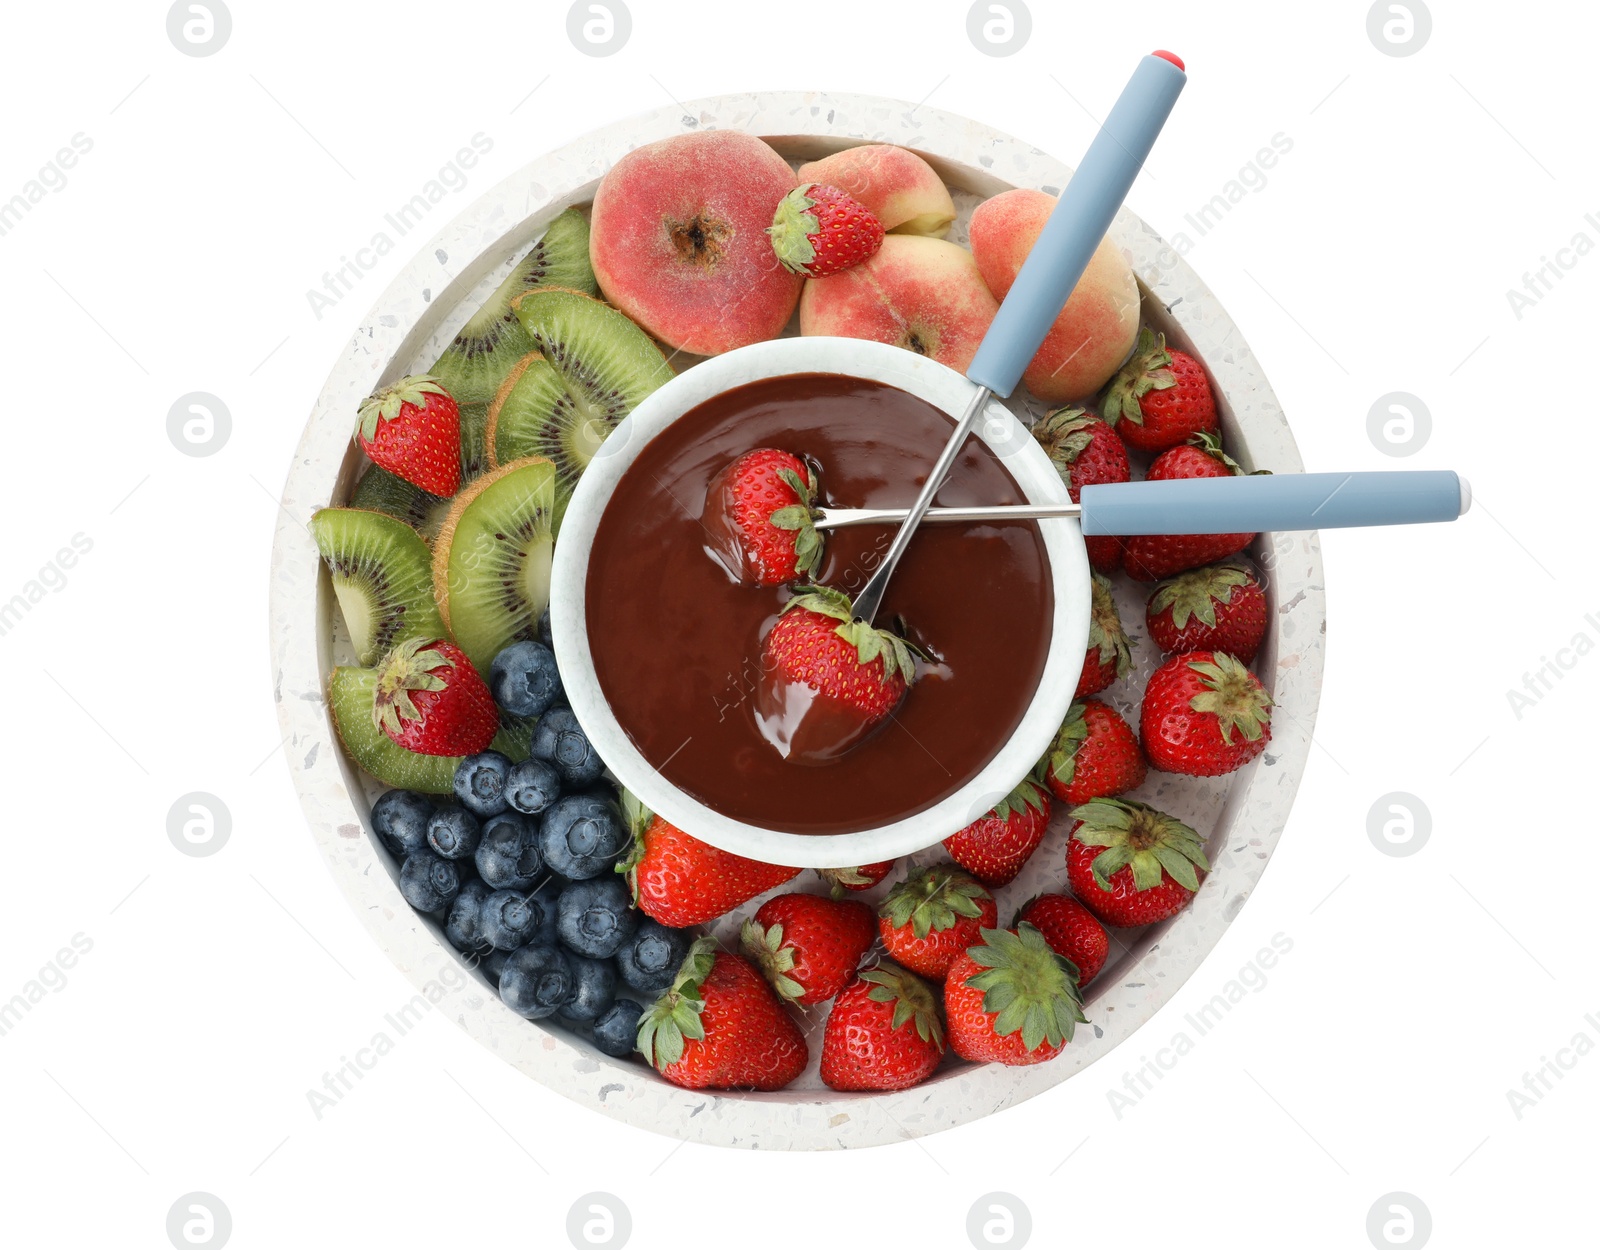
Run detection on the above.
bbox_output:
[971,187,1139,403]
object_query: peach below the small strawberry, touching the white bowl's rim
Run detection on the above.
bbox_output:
[800,234,1000,373]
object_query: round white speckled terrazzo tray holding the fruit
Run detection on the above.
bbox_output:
[270,93,1325,1149]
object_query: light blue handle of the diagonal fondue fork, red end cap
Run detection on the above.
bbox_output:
[966,54,1187,397]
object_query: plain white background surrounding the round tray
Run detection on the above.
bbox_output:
[0,0,1600,1247]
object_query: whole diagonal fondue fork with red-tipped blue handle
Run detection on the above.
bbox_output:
[854,53,1190,624]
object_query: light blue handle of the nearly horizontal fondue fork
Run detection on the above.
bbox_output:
[1080,469,1472,535]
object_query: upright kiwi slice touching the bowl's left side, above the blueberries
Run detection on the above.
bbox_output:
[434,456,555,674]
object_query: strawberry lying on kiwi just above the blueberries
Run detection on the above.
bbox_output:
[373,639,499,755]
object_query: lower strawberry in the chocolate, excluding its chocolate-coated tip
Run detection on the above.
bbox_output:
[762,586,917,731]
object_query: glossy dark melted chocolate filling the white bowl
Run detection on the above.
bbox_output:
[587,373,1054,834]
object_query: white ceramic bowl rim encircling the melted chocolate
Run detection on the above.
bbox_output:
[550,338,1090,867]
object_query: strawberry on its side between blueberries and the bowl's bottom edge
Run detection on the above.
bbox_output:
[616,811,800,928]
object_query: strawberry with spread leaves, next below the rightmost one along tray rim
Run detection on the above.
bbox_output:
[1067,799,1210,928]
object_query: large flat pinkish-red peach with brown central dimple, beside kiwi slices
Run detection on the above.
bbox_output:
[589,130,805,355]
